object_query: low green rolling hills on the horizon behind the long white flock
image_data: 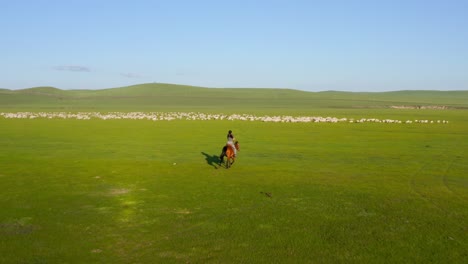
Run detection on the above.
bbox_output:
[0,83,468,112]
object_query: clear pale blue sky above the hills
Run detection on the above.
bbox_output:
[0,0,468,92]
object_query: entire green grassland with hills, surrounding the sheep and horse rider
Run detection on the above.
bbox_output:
[0,84,468,263]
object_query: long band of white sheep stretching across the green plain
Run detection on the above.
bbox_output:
[0,112,448,124]
